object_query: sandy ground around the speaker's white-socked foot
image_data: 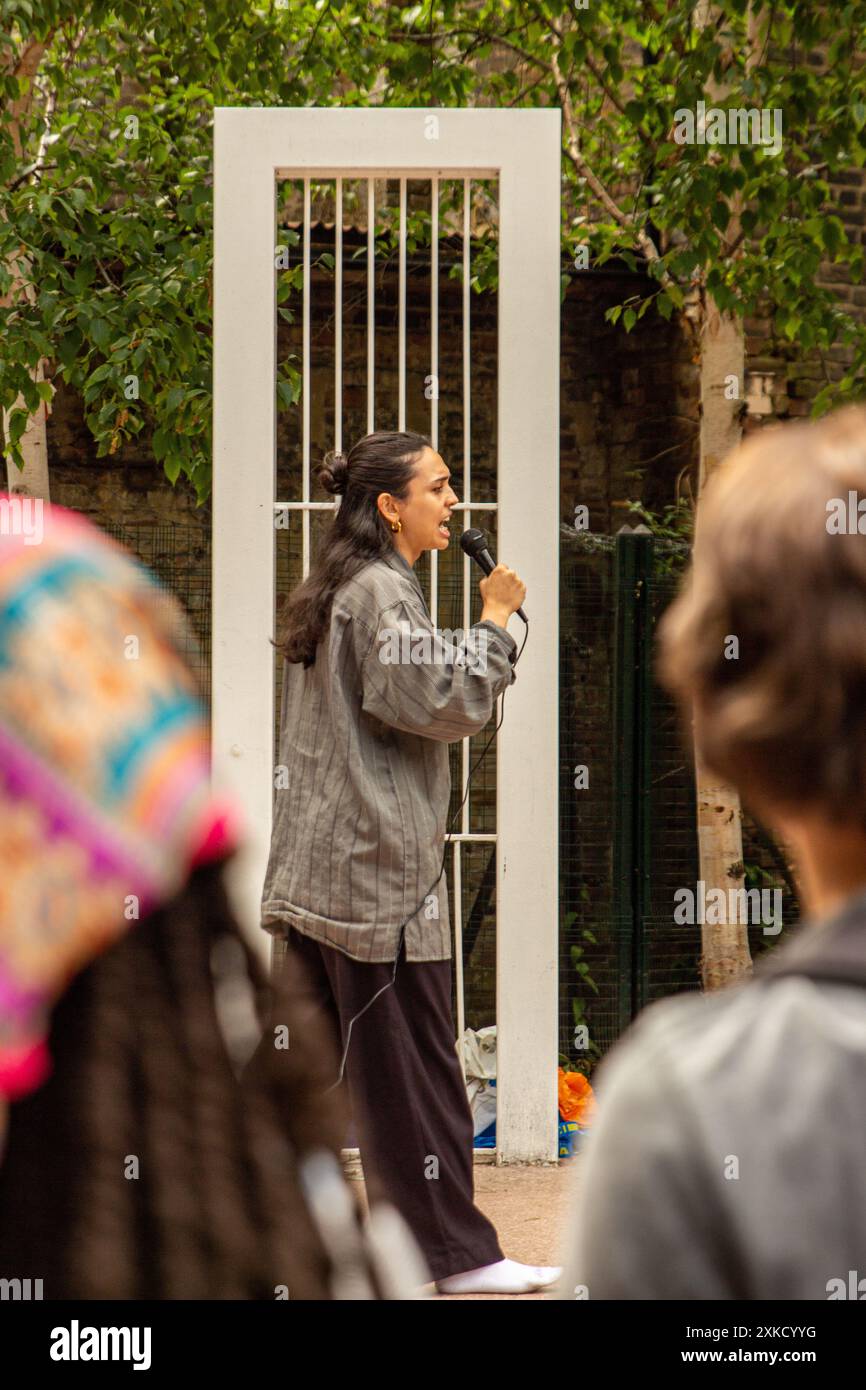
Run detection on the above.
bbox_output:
[348,1155,581,1302]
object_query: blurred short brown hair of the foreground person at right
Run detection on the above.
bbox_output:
[657,406,866,826]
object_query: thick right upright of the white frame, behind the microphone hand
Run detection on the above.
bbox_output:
[496,110,562,1163]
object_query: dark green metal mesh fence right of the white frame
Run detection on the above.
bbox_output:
[559,525,798,1070]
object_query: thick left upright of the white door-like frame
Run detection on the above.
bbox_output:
[211,108,277,969]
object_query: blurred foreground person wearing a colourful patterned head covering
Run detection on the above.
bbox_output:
[0,498,423,1300]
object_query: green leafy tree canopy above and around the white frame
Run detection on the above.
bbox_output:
[0,0,866,500]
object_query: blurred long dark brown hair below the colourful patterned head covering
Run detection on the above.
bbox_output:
[0,863,354,1300]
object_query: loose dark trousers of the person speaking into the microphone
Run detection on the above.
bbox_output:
[280,927,505,1279]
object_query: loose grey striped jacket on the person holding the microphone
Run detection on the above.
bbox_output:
[261,549,517,960]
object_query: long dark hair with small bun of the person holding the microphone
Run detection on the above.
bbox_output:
[272,430,430,666]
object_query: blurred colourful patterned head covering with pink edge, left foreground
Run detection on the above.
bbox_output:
[0,493,239,1098]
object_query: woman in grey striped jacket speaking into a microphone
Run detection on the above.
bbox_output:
[261,431,559,1293]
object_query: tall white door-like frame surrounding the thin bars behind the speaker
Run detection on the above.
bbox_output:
[211,107,562,1163]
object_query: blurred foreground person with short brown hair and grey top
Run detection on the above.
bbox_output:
[559,406,866,1300]
